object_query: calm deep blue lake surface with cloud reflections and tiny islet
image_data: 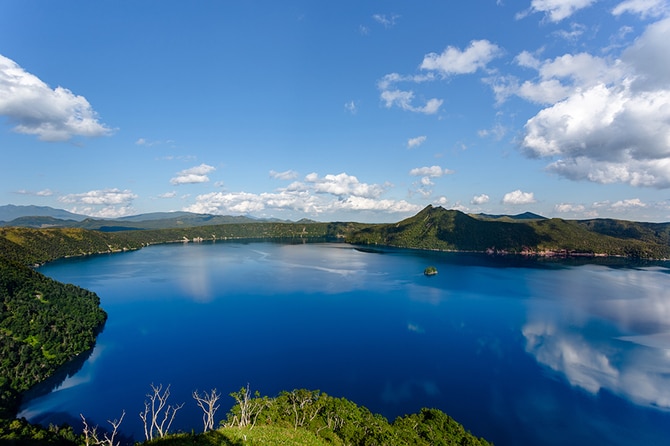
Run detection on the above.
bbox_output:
[19,242,670,446]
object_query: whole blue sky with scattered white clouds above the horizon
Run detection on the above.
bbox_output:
[0,0,670,222]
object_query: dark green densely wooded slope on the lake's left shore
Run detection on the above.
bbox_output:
[0,260,106,415]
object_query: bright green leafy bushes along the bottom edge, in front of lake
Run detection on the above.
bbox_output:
[150,389,489,446]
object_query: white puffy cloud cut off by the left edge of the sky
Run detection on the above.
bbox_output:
[0,55,112,141]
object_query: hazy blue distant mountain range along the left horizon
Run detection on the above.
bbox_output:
[0,204,306,232]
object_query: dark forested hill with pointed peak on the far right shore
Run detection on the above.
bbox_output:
[347,206,670,259]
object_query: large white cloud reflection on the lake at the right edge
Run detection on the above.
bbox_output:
[522,267,670,409]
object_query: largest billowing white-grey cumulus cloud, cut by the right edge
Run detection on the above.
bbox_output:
[521,18,670,188]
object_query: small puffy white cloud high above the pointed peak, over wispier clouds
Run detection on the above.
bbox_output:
[421,40,501,75]
